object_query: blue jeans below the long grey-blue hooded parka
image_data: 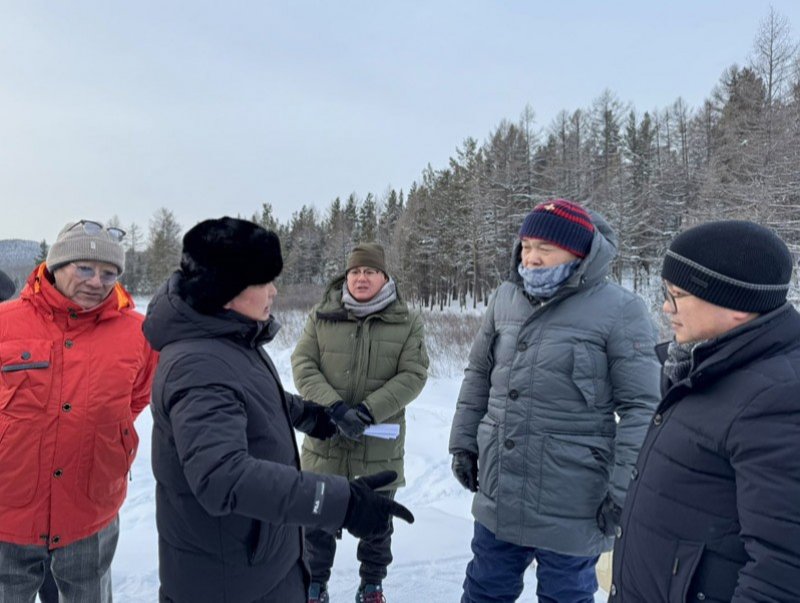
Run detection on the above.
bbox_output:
[461,521,599,603]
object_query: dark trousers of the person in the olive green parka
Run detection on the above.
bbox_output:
[306,490,396,584]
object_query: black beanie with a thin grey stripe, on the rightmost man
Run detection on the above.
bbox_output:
[661,220,794,313]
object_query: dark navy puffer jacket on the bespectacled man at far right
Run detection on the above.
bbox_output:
[609,304,800,603]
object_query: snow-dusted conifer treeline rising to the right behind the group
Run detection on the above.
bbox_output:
[42,10,800,307]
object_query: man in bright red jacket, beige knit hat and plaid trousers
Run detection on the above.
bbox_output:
[0,220,157,603]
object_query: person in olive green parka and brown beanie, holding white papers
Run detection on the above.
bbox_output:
[292,243,428,603]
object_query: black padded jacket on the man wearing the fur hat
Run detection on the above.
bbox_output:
[144,272,350,603]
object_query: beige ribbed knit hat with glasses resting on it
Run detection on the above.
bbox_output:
[47,220,125,274]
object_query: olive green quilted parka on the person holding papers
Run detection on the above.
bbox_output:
[292,276,428,489]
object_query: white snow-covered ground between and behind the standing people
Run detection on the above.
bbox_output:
[113,305,606,603]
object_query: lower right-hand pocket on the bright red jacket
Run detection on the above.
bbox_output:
[86,420,139,506]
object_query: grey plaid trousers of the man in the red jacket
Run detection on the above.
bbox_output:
[0,517,119,603]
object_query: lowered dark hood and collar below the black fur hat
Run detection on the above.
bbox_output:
[142,270,280,352]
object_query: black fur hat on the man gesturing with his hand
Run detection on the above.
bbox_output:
[179,216,283,314]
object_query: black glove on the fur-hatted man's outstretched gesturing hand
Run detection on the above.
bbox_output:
[342,471,414,538]
